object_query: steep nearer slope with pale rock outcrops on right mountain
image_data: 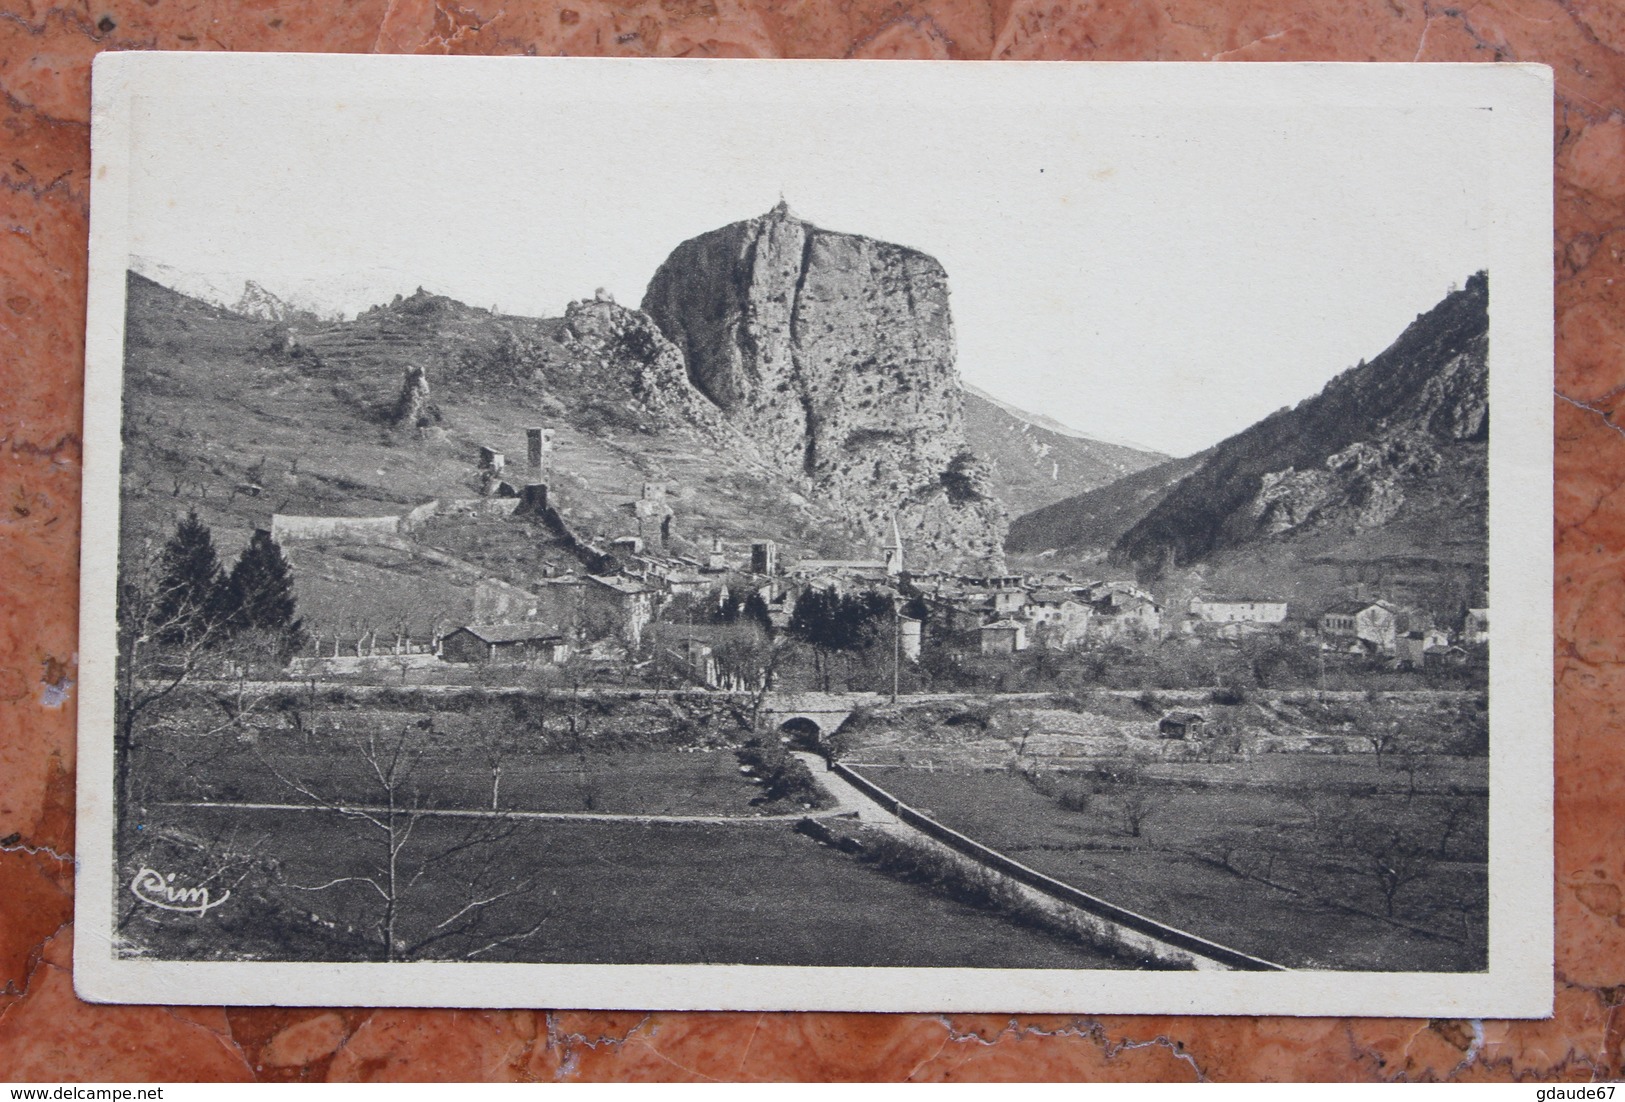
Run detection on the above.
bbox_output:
[1113,271,1489,569]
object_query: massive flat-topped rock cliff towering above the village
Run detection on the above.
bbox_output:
[644,203,1004,566]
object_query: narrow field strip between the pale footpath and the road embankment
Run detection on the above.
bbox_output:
[133,686,763,814]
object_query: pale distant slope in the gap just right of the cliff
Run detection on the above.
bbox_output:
[965,385,1167,520]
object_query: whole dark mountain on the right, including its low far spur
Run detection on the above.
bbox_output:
[1006,271,1489,611]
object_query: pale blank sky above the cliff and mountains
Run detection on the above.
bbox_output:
[127,57,1527,455]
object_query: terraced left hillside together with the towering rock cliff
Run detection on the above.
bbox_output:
[122,194,1027,626]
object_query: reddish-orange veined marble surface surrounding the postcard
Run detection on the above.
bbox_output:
[0,0,1625,1081]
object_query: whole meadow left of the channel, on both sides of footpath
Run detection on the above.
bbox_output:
[117,691,1121,967]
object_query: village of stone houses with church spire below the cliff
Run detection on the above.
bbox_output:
[250,427,1489,692]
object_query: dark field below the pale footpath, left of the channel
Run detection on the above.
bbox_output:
[120,809,1121,969]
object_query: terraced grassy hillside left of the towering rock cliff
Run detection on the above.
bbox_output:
[124,273,897,584]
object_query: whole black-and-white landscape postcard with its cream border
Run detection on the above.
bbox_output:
[75,54,1552,1016]
